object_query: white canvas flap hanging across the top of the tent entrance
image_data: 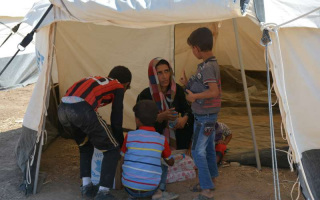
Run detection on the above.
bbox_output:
[51,0,241,28]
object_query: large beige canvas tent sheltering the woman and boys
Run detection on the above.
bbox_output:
[17,0,320,199]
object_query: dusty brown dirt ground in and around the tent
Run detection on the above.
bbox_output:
[0,85,303,200]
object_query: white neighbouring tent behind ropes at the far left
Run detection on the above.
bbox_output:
[0,0,39,90]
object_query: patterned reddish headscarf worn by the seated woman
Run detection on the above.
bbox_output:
[148,57,177,112]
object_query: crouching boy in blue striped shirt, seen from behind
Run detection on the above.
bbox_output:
[121,100,179,200]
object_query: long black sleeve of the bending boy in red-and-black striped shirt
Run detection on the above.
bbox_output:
[110,88,124,148]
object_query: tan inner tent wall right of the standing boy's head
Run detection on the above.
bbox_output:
[215,17,266,71]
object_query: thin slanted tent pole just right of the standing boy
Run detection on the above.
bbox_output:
[232,18,261,170]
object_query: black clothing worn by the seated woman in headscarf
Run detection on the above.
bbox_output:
[137,84,194,149]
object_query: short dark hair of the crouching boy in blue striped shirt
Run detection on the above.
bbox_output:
[133,100,158,126]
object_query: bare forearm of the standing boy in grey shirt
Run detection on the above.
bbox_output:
[186,83,219,102]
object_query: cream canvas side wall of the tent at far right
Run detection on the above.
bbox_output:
[270,28,320,161]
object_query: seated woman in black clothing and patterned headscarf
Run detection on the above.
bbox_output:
[137,57,193,149]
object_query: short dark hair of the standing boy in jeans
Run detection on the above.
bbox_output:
[187,27,213,51]
